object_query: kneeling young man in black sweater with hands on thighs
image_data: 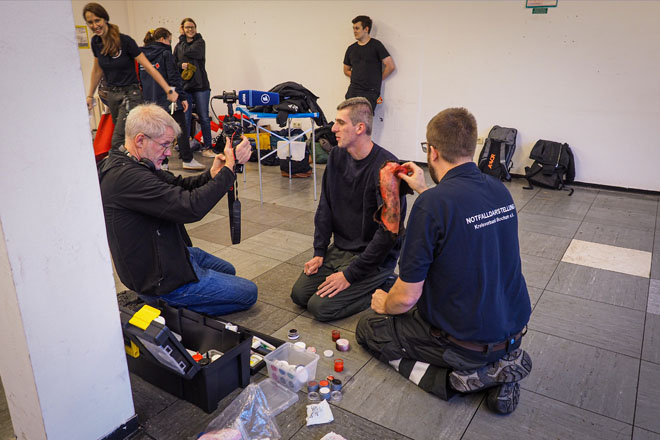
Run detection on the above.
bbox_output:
[291,97,406,321]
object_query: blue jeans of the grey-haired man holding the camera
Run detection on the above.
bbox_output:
[159,247,257,316]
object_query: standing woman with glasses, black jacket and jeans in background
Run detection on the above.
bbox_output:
[174,18,215,157]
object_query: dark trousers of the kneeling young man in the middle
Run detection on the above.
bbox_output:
[291,246,392,321]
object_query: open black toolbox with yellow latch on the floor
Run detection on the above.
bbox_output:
[120,302,252,413]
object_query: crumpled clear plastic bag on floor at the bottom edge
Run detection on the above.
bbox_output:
[199,384,281,440]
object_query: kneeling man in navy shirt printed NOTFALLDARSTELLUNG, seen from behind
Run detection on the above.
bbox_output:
[356,108,532,414]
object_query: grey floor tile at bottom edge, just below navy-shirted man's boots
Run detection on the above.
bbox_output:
[337,359,483,440]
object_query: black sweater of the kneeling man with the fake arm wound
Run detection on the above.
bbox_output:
[314,144,406,283]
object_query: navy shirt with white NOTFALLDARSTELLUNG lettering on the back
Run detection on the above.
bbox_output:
[399,162,531,343]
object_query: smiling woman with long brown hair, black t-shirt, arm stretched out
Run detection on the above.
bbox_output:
[83,3,179,148]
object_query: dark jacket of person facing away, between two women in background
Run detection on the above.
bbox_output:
[140,41,186,112]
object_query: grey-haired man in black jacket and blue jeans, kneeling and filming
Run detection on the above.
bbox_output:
[99,104,257,316]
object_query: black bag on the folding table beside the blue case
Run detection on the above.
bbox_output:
[248,81,328,127]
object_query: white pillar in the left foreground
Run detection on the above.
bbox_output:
[0,1,135,440]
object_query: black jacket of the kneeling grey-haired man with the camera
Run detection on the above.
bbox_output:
[99,150,234,295]
